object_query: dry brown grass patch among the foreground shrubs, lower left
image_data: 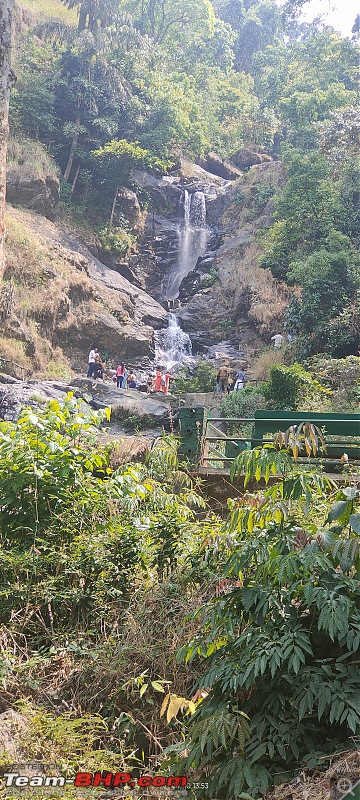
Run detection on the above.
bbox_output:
[0,583,209,762]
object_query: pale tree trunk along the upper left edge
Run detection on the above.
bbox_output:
[0,0,14,283]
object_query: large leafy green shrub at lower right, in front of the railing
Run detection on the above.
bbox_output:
[169,448,360,798]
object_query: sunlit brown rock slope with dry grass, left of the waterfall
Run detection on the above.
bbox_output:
[0,208,166,377]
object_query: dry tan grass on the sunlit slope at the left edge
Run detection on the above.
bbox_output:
[1,207,114,380]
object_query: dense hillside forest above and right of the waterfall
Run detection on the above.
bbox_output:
[7,0,360,359]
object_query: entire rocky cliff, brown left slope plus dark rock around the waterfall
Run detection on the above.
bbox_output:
[0,149,289,384]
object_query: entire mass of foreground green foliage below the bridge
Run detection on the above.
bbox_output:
[0,390,360,799]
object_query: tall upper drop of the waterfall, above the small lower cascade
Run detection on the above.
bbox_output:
[163,189,210,300]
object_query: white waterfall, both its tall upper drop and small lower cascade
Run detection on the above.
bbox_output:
[155,189,210,369]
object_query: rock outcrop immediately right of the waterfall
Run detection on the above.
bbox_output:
[177,161,290,352]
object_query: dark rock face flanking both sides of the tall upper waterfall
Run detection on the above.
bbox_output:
[132,159,289,352]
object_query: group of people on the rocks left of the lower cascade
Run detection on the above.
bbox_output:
[87,347,173,394]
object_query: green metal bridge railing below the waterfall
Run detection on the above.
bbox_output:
[179,407,360,473]
